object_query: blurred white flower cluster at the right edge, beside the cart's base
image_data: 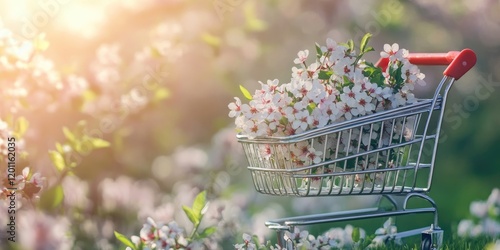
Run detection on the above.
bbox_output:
[457,188,500,237]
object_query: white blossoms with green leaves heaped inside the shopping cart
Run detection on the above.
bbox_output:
[228,34,425,192]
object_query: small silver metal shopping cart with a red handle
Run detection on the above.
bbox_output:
[237,49,476,249]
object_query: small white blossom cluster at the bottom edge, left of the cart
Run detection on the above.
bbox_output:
[127,217,203,250]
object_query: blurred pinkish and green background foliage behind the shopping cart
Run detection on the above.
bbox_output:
[0,0,500,248]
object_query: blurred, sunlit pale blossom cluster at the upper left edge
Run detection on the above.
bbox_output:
[0,23,88,113]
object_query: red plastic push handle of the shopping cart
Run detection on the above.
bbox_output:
[376,49,477,80]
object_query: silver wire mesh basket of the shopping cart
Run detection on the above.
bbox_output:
[238,77,454,196]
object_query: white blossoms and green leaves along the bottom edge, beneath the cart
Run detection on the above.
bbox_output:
[118,191,402,250]
